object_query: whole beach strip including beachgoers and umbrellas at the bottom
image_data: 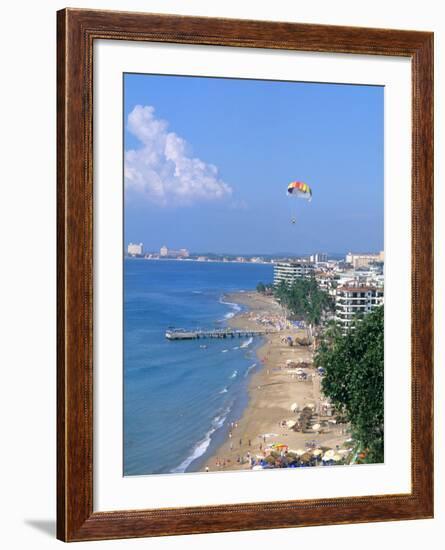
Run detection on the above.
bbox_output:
[203,292,356,472]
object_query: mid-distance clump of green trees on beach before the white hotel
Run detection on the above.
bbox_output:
[274,277,334,325]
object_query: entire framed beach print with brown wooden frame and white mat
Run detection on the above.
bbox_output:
[57,9,433,541]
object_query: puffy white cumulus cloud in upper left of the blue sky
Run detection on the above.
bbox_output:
[125,105,232,205]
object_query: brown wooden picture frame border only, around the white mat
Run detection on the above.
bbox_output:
[57,9,433,541]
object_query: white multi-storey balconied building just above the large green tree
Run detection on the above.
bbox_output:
[335,284,384,333]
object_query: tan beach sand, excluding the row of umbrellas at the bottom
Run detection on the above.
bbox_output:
[202,292,350,471]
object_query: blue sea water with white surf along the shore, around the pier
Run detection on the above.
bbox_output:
[124,259,273,475]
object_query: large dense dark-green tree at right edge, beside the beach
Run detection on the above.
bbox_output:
[315,306,384,463]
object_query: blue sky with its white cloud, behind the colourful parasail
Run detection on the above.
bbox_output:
[124,74,384,254]
